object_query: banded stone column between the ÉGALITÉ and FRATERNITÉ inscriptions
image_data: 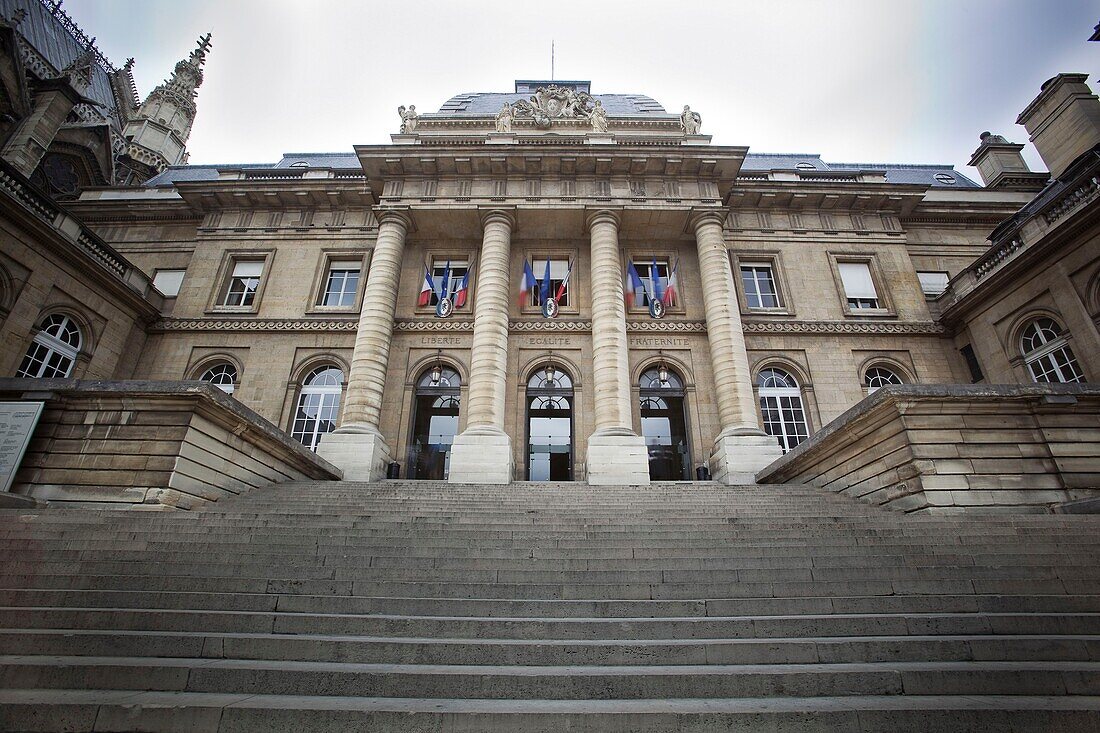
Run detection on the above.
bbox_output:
[587,209,649,484]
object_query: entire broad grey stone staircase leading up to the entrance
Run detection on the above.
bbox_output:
[0,481,1100,733]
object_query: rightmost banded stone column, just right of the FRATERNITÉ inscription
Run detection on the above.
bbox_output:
[692,210,783,483]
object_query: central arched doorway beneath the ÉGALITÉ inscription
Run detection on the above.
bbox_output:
[527,363,573,481]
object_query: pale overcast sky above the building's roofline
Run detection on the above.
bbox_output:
[64,0,1100,179]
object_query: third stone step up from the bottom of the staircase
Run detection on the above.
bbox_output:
[0,628,1100,666]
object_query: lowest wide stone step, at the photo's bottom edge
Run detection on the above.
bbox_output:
[8,688,1100,733]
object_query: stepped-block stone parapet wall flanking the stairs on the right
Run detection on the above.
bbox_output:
[757,384,1100,514]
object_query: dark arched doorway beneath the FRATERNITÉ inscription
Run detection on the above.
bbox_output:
[639,363,691,481]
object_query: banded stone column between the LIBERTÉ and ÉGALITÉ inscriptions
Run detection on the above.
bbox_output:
[449,209,515,483]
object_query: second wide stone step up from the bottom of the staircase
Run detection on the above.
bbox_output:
[8,656,1100,700]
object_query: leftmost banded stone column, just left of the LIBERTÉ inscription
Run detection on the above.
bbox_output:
[317,205,413,481]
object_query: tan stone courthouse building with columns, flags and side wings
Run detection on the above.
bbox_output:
[0,3,1100,501]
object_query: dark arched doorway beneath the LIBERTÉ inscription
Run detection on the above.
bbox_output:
[408,364,462,481]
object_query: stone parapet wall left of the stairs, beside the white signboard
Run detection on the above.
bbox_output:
[0,379,341,510]
